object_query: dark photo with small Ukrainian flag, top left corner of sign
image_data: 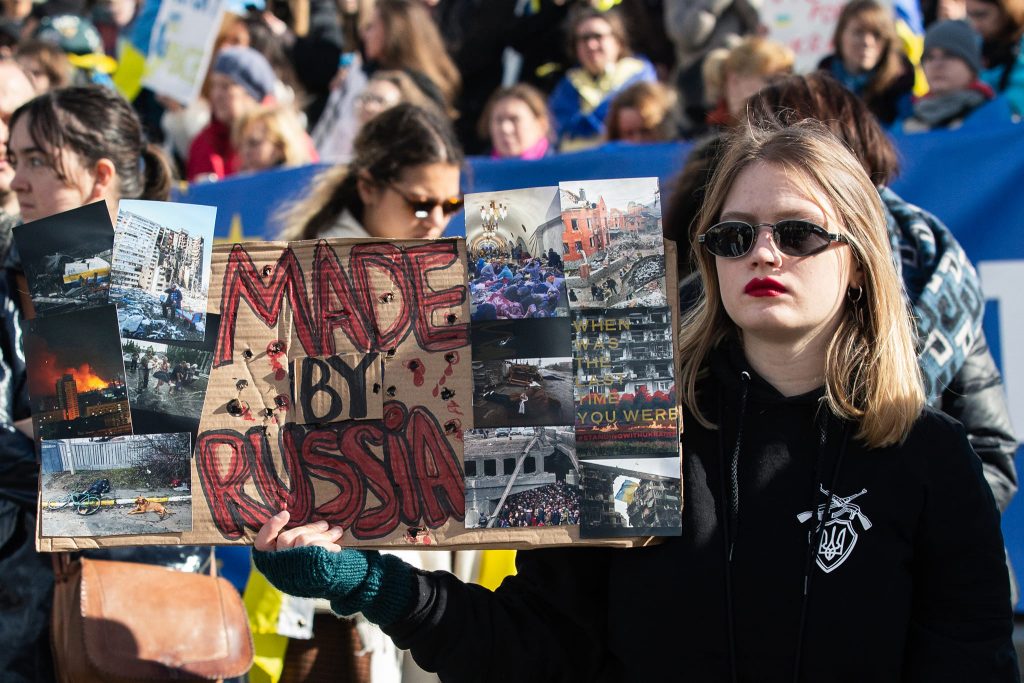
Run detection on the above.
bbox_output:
[13,202,114,315]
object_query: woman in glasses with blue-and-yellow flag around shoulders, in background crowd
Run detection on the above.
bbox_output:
[548,5,657,152]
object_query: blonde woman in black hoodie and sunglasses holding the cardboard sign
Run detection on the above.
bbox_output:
[247,121,1018,683]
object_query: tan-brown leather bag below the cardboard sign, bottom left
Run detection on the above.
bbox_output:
[51,555,253,683]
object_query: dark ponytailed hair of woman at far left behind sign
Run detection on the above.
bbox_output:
[9,85,171,201]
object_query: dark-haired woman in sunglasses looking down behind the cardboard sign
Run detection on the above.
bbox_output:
[282,103,463,241]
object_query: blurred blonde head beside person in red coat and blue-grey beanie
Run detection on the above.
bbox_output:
[231,105,316,172]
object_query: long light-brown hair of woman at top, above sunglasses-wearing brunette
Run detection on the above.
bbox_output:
[376,0,462,114]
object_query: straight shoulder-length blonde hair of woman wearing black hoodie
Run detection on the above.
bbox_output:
[680,120,925,447]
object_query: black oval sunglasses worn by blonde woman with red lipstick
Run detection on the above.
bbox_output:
[697,218,849,258]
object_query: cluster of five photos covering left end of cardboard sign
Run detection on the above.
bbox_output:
[14,201,218,537]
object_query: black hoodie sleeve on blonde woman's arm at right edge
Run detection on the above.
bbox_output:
[903,413,1020,683]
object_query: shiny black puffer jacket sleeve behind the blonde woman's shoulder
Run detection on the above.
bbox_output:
[940,332,1017,512]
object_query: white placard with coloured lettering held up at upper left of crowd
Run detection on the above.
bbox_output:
[142,0,227,104]
